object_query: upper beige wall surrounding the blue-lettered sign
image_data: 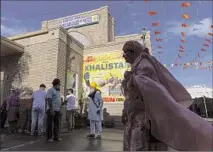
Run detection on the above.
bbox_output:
[42,6,112,45]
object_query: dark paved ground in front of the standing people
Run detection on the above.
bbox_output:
[1,129,123,151]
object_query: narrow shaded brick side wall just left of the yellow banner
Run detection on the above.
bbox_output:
[57,29,83,98]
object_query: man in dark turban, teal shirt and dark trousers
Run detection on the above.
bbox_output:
[46,78,61,142]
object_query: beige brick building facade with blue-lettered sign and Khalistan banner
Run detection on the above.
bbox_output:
[1,6,152,115]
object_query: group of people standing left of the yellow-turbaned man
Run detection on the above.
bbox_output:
[1,78,76,142]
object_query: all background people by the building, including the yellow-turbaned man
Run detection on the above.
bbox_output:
[1,78,103,142]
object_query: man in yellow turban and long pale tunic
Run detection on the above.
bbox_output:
[87,82,103,139]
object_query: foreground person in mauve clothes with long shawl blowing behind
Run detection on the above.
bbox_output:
[122,41,213,151]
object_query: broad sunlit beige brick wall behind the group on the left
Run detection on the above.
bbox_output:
[7,29,59,94]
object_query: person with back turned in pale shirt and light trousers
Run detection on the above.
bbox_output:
[31,84,46,136]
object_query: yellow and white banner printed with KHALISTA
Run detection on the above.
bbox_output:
[83,51,130,102]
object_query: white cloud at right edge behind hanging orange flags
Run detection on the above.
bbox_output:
[167,18,212,37]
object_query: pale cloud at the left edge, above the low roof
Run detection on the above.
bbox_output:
[1,17,30,37]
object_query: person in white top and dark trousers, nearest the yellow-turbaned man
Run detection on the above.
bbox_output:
[66,89,76,132]
